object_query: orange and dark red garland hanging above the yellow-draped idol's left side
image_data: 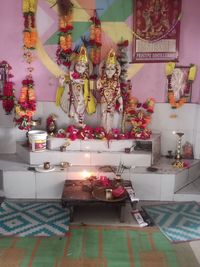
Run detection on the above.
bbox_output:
[56,0,73,69]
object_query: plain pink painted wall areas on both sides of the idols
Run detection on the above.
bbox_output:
[0,0,200,103]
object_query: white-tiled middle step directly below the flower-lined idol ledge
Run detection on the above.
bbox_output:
[17,142,152,166]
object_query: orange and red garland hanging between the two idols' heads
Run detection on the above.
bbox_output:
[89,9,102,79]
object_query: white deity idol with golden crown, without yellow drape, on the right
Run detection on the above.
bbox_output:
[97,49,123,133]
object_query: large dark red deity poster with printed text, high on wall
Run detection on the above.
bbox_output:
[132,0,181,63]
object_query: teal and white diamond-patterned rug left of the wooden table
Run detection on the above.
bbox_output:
[0,201,69,237]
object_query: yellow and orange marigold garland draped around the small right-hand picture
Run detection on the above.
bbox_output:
[165,62,197,109]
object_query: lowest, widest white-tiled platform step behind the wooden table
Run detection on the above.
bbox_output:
[0,155,200,201]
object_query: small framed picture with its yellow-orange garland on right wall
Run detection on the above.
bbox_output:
[165,62,197,109]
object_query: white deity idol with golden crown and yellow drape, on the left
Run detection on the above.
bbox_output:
[60,47,96,127]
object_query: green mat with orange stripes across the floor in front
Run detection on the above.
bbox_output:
[0,226,199,267]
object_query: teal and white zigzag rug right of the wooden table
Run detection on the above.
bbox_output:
[142,202,200,242]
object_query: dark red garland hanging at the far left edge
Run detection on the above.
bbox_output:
[0,60,15,115]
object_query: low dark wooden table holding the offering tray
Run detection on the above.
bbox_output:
[61,180,136,222]
